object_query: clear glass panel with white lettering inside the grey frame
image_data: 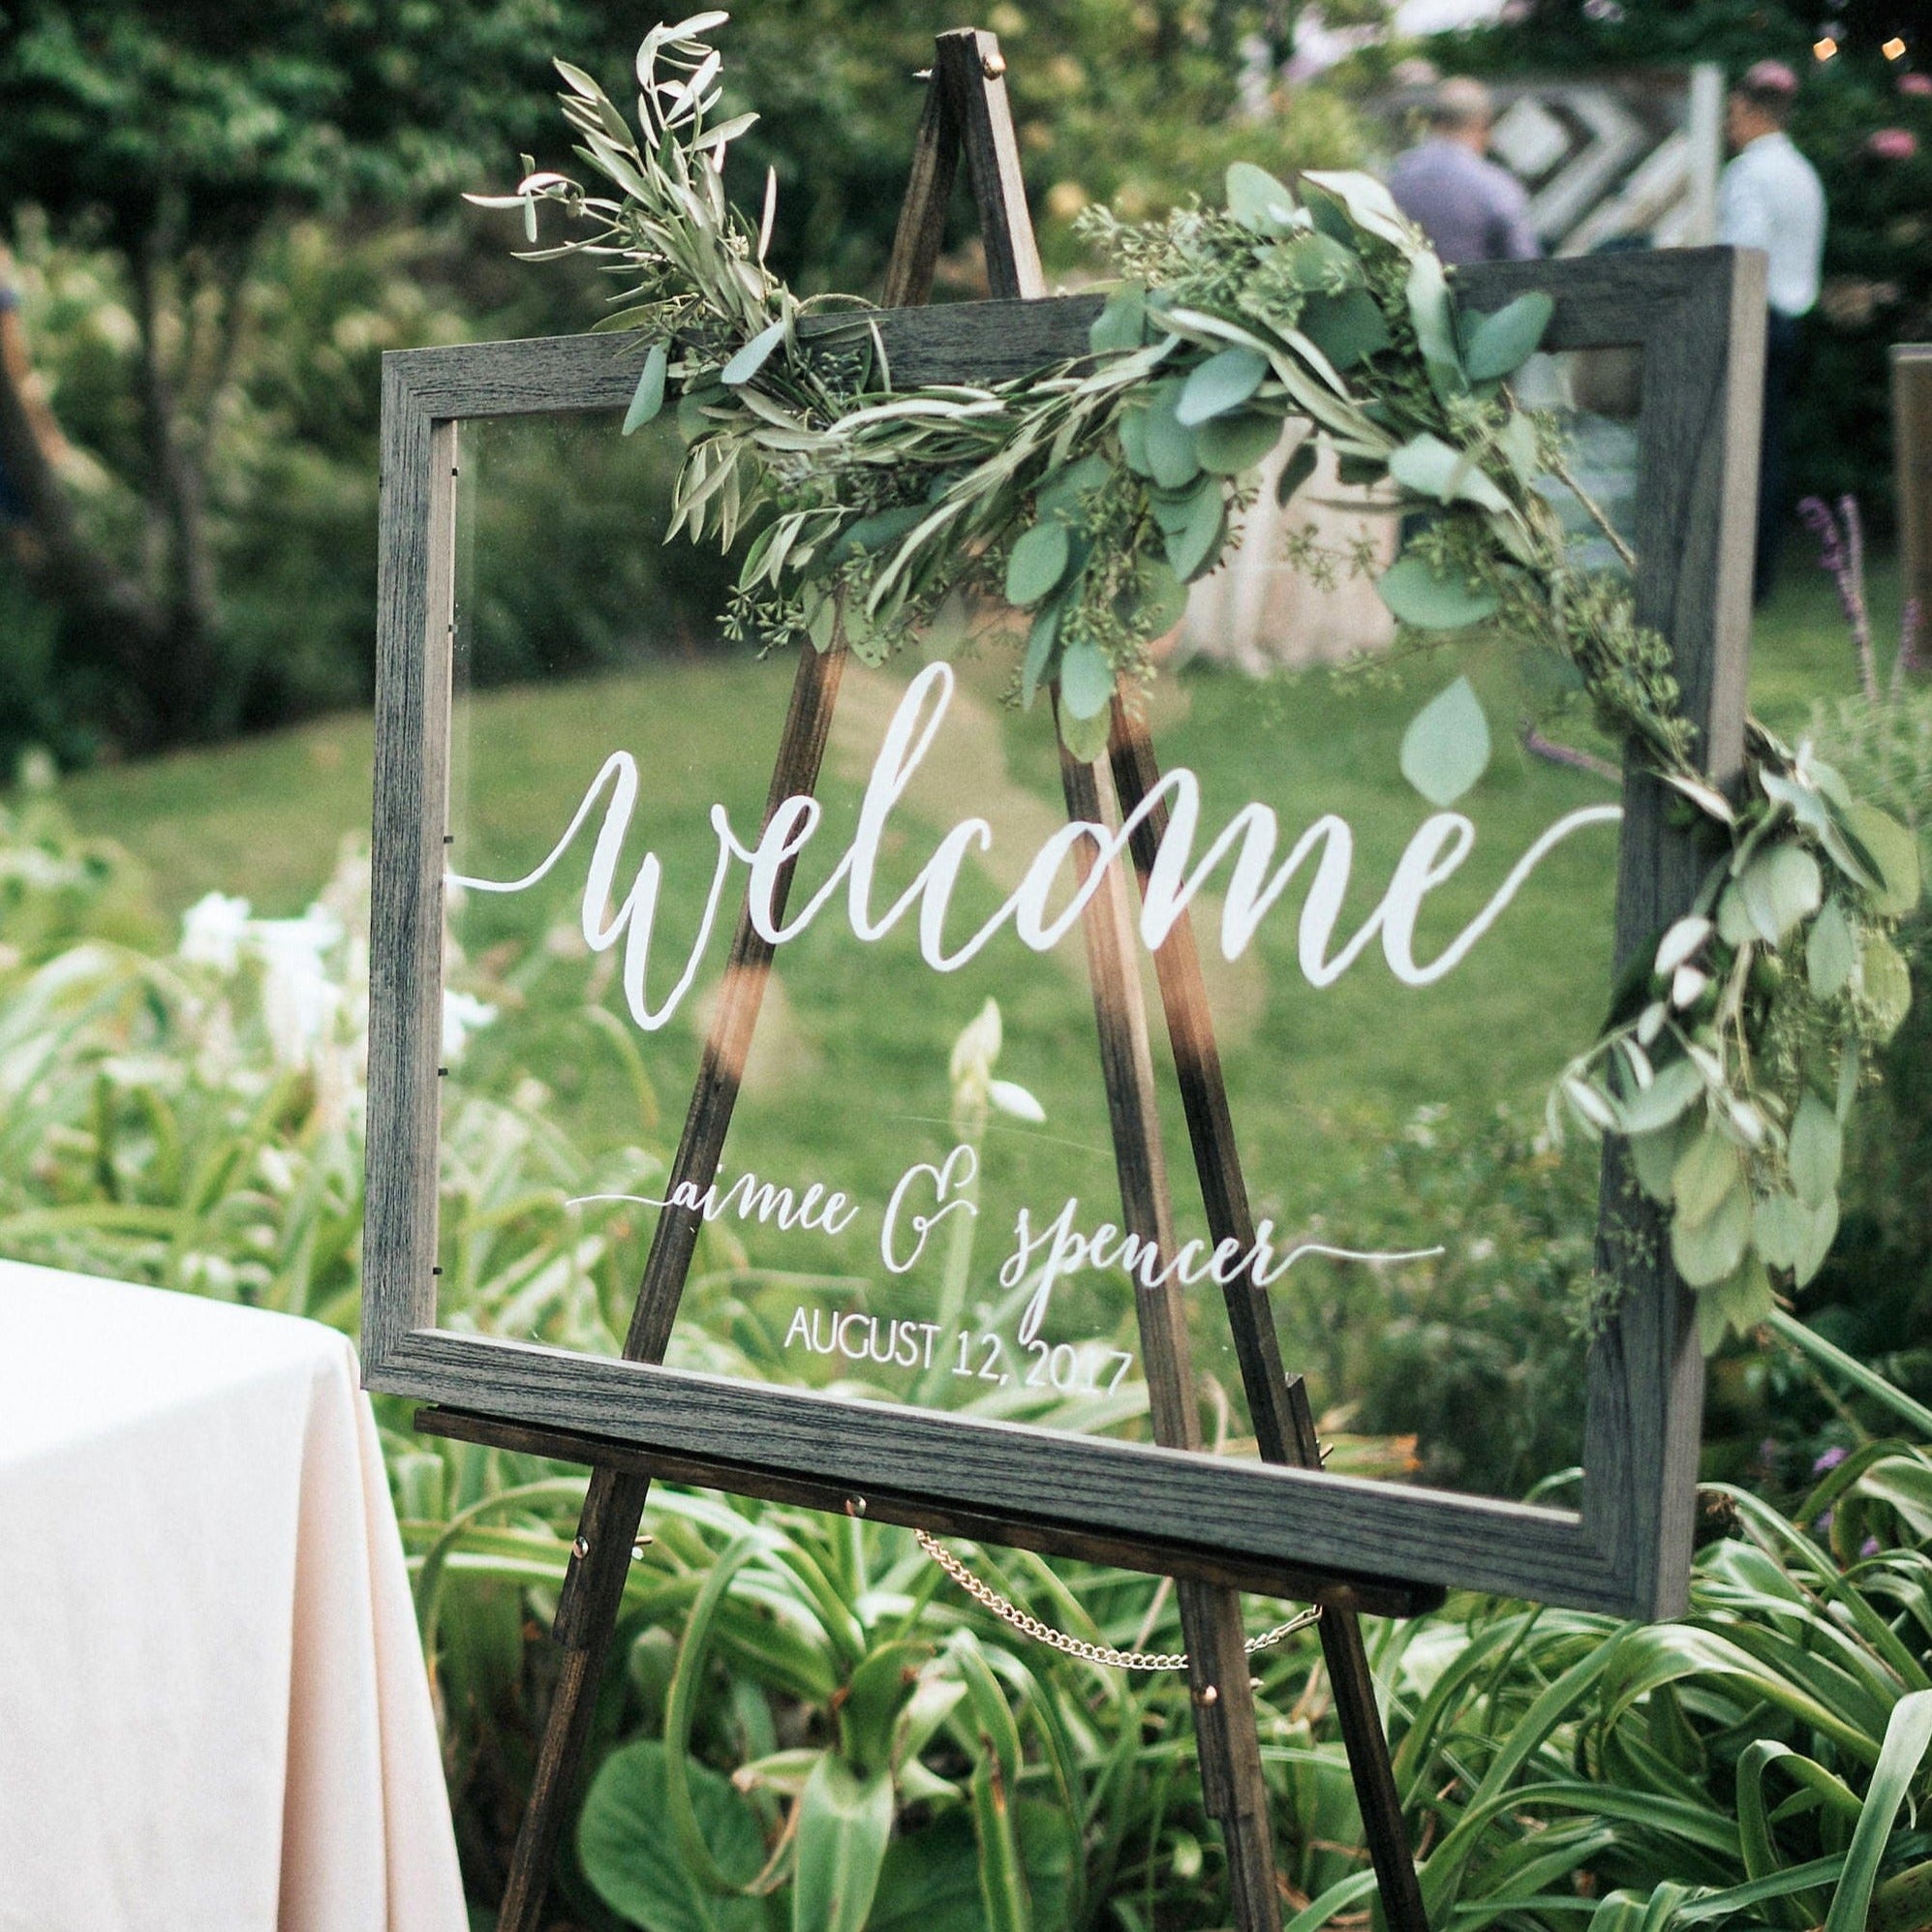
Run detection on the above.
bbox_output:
[443,391,1617,1495]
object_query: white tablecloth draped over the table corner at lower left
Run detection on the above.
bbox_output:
[0,1262,466,1932]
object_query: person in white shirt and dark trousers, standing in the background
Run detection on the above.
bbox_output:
[1718,60,1824,602]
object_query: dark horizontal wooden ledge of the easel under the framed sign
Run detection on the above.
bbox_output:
[415,1404,1445,1617]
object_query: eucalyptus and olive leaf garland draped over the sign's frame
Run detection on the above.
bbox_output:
[474,14,1918,1347]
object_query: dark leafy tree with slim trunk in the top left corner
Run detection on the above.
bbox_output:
[0,0,618,746]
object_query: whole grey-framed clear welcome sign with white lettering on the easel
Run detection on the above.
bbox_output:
[365,253,1769,1613]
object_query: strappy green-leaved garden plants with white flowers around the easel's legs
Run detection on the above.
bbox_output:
[11,750,1932,1932]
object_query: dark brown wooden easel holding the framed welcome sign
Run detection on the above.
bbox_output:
[438,29,1439,1932]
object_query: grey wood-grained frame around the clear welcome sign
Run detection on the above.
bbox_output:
[363,249,1765,1617]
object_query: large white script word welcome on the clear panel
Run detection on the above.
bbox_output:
[450,662,1623,1031]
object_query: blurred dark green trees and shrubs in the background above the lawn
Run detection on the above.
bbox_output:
[0,0,1932,773]
